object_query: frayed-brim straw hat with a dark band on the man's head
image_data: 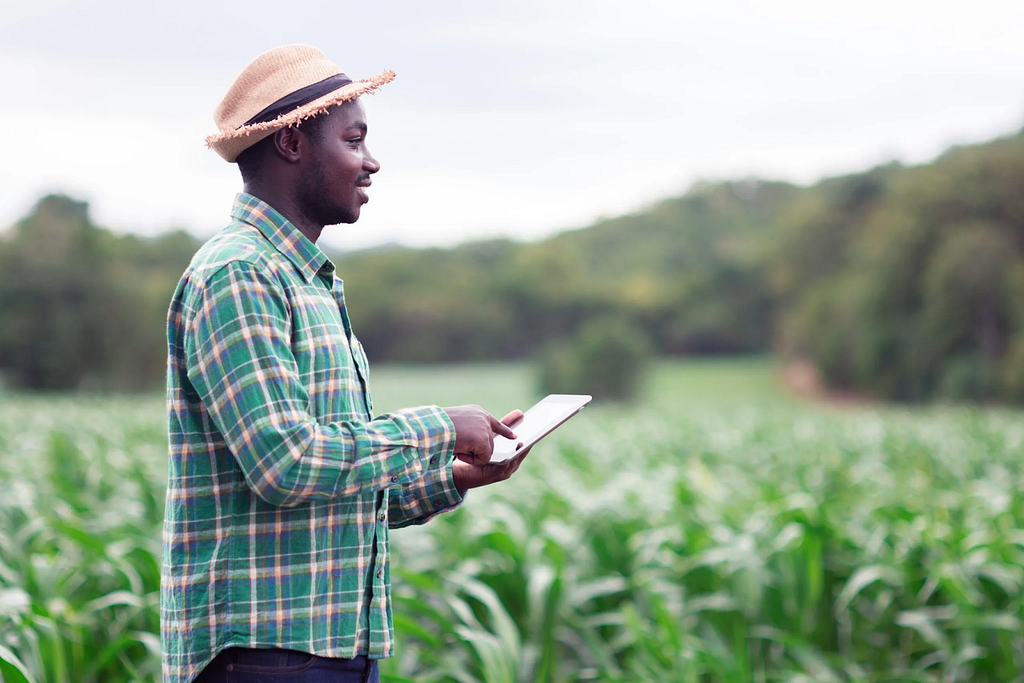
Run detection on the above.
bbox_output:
[206,45,394,162]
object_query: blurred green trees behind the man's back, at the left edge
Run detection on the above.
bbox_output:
[0,196,197,391]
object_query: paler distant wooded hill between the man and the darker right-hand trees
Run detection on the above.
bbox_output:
[338,179,802,360]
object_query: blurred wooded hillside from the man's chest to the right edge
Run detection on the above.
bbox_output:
[339,127,1024,400]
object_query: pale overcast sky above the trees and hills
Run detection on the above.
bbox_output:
[0,0,1024,250]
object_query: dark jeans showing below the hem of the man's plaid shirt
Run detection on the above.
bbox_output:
[194,647,381,683]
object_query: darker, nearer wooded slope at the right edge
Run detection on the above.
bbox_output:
[766,132,1024,401]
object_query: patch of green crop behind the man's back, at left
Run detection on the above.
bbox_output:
[0,396,166,683]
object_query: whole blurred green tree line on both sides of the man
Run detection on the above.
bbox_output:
[0,131,1024,402]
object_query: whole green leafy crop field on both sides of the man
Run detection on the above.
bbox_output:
[0,359,1024,683]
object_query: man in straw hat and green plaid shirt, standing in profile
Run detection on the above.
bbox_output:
[161,45,525,683]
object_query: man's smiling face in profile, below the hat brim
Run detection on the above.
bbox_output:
[299,98,380,225]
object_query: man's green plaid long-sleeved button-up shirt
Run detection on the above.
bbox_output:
[160,195,462,683]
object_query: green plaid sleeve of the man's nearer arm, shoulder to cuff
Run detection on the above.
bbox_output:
[184,262,455,506]
